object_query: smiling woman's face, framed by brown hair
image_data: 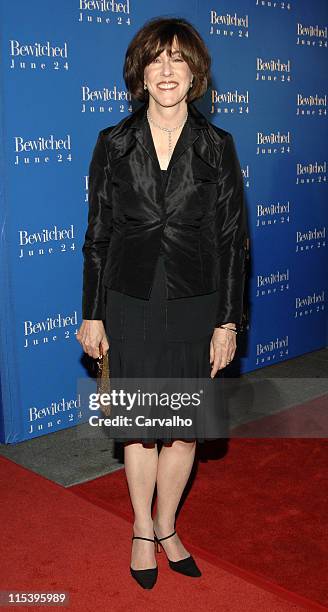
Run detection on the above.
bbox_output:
[144,41,193,106]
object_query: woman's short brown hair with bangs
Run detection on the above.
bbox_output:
[123,17,211,102]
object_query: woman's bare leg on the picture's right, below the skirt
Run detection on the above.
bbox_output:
[154,440,196,561]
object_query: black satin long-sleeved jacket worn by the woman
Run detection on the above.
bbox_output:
[82,102,248,328]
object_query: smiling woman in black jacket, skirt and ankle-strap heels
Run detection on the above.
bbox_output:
[77,18,247,588]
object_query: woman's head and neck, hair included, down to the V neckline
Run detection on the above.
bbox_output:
[124,19,211,170]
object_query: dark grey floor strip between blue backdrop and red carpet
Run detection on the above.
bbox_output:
[0,349,328,487]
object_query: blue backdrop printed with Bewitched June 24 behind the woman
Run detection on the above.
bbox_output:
[0,0,328,443]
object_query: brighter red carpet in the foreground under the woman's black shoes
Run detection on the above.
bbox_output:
[0,457,316,612]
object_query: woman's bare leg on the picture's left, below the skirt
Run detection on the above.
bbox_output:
[124,442,158,569]
